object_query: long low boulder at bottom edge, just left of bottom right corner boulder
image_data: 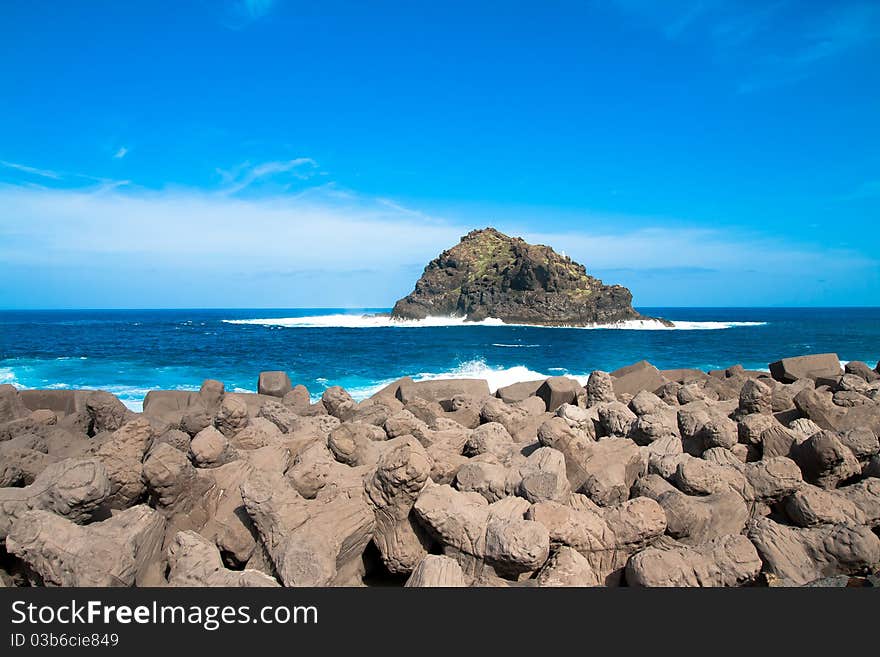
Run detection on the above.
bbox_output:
[626,535,761,587]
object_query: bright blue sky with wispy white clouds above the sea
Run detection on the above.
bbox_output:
[0,0,880,308]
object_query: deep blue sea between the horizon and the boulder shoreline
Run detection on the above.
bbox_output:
[0,308,880,409]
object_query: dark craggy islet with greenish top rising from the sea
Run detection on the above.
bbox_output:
[392,228,660,325]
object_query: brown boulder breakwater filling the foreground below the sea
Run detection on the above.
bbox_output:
[0,354,880,586]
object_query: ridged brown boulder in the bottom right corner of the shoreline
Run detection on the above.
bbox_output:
[748,518,880,585]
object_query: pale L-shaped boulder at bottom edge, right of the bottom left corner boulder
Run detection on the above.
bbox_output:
[168,531,278,587]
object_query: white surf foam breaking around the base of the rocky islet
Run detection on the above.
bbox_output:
[222,314,767,330]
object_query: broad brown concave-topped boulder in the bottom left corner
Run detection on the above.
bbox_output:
[6,505,165,586]
